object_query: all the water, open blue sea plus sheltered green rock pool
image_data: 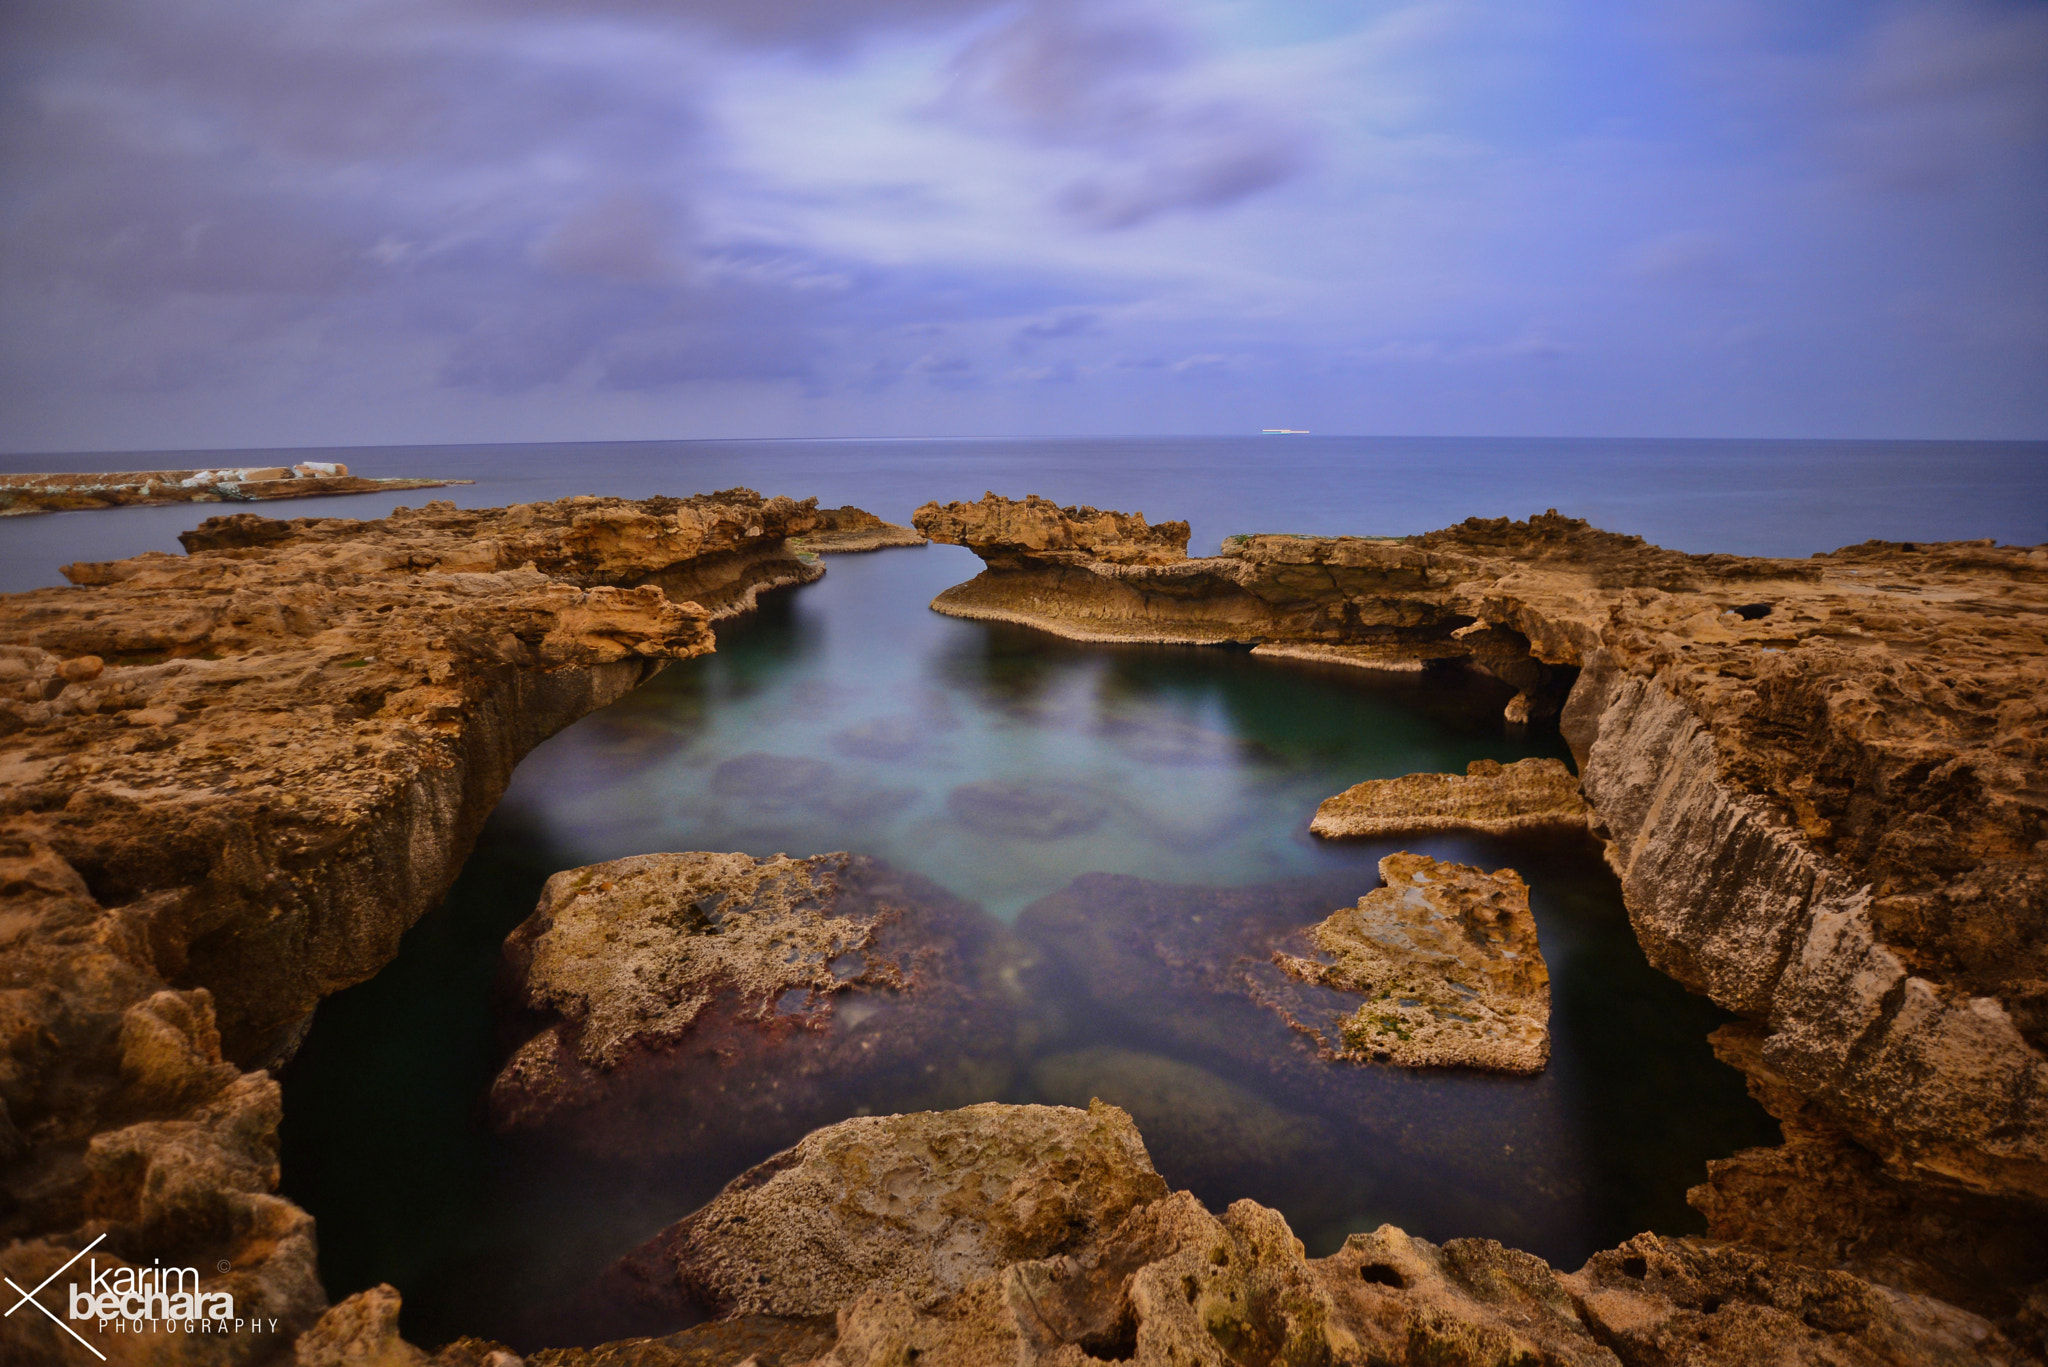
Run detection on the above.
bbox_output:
[0,434,2048,1351]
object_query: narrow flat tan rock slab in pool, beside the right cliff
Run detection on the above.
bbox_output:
[1309,758,1585,840]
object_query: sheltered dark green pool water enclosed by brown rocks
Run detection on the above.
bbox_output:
[285,547,1776,1349]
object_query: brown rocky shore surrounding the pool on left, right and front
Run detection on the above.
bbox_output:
[0,490,2048,1367]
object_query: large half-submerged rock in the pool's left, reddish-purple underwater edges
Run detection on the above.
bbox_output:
[489,853,1014,1158]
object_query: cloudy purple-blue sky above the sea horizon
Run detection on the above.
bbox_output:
[0,0,2048,453]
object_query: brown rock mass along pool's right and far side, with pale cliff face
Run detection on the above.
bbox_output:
[920,500,2048,1334]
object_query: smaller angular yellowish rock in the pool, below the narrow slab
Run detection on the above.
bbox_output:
[1274,855,1550,1072]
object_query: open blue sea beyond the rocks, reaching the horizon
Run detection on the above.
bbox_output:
[0,437,2048,590]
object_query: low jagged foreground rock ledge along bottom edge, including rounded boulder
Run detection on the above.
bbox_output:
[315,1101,2025,1367]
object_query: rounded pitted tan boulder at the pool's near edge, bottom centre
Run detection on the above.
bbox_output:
[625,1103,1165,1316]
